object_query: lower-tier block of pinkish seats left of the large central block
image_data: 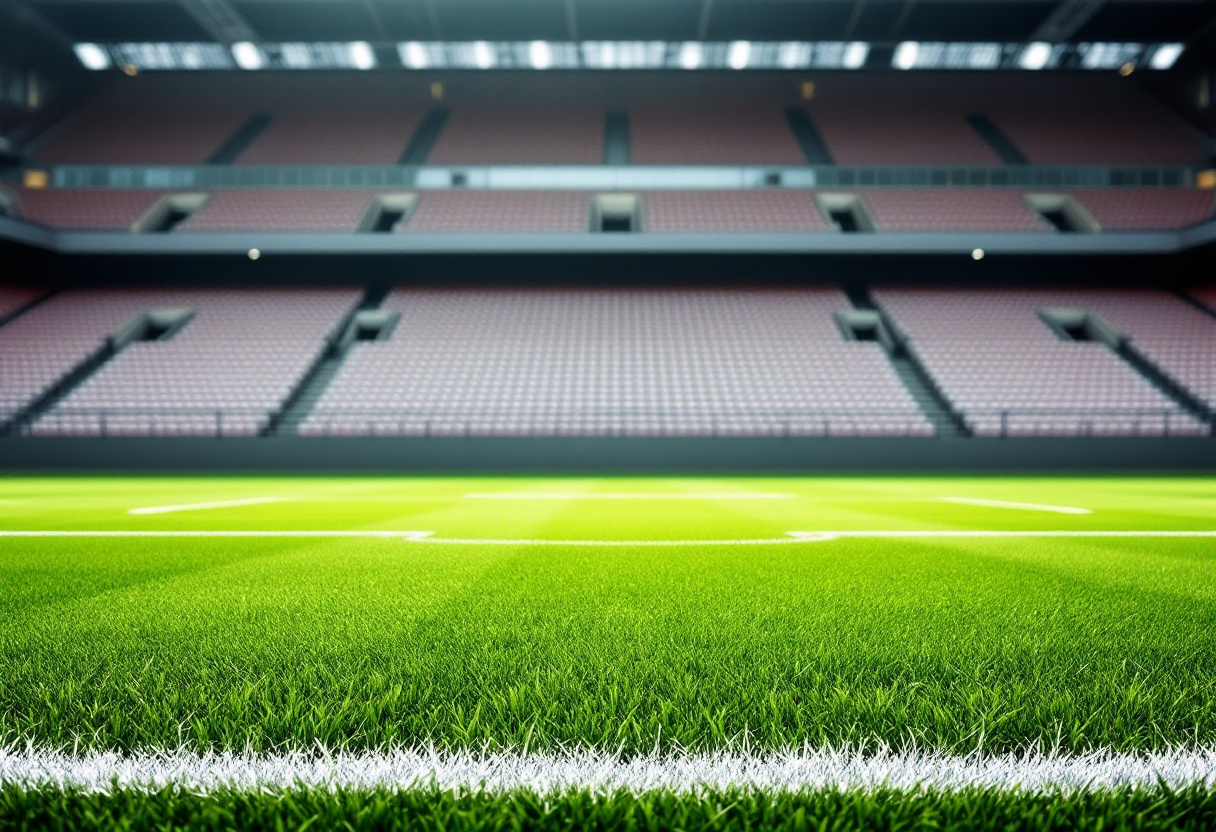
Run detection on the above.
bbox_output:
[28,289,360,437]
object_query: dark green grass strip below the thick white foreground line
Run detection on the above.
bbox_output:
[0,785,1216,832]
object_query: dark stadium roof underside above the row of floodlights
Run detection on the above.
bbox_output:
[13,0,1216,51]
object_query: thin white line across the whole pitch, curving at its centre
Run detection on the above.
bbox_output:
[0,529,1216,546]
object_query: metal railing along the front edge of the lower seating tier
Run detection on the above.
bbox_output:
[7,407,1216,438]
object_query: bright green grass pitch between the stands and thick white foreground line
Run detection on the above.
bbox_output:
[0,477,1216,828]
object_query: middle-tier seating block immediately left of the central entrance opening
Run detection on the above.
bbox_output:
[401,191,591,232]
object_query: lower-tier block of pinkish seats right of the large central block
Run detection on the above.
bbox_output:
[874,288,1210,437]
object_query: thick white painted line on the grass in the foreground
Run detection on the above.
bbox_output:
[0,747,1216,794]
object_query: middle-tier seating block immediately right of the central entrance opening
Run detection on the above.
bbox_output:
[642,191,835,231]
